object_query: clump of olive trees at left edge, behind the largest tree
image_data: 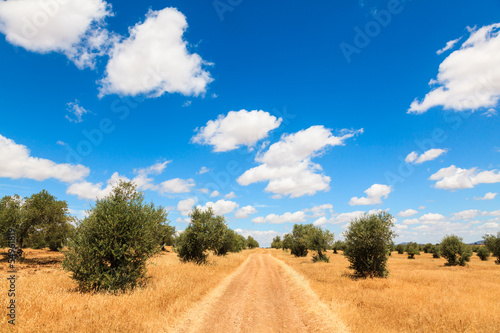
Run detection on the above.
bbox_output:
[0,190,76,253]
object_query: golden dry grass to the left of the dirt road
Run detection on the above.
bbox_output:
[0,245,255,333]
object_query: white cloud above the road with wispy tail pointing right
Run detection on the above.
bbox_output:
[238,126,363,198]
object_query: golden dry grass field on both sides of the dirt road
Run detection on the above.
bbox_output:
[0,249,500,333]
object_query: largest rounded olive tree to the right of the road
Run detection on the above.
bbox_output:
[344,212,396,277]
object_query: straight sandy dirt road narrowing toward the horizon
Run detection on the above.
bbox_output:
[174,253,347,333]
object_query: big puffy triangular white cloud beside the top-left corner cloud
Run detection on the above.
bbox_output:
[100,8,213,97]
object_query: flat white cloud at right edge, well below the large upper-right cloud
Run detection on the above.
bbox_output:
[429,165,500,190]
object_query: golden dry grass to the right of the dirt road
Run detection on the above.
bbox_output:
[270,250,500,333]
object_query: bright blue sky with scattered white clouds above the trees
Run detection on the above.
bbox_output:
[0,0,500,246]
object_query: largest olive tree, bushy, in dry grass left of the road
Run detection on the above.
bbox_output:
[63,181,167,291]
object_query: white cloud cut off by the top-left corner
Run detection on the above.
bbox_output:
[0,0,113,68]
